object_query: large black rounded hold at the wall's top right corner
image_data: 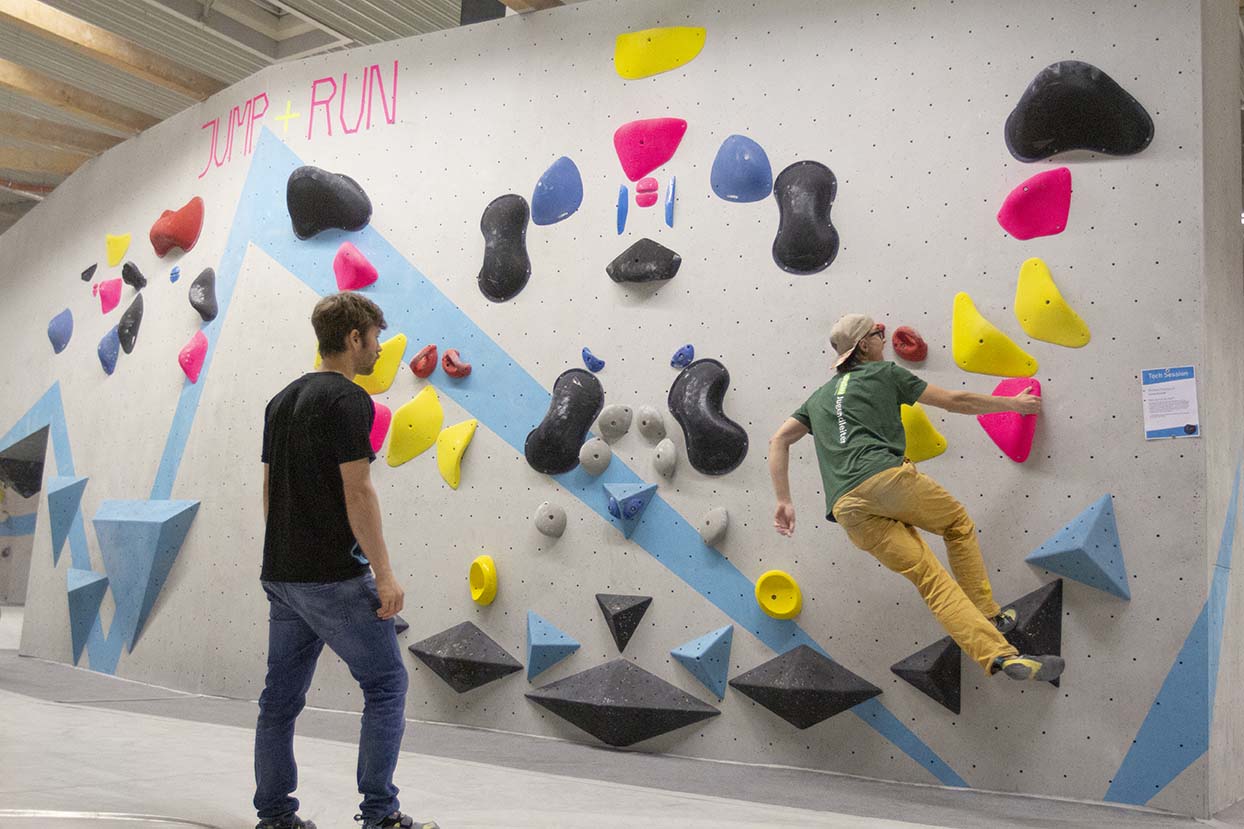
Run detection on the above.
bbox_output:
[1005,61,1153,162]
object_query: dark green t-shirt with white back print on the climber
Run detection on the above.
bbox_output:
[791,360,928,522]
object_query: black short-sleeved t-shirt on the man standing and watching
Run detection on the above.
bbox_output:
[260,371,376,581]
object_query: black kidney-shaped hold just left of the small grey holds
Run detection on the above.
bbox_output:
[522,368,605,475]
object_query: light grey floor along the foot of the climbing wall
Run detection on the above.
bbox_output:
[0,607,1244,829]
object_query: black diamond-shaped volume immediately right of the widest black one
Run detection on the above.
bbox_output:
[730,645,881,728]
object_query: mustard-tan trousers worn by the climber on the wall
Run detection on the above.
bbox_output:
[833,461,1018,673]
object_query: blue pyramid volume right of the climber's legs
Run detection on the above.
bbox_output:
[1024,493,1132,600]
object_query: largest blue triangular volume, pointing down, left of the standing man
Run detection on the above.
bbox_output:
[92,500,199,651]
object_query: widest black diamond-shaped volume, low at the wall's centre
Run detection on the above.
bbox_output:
[526,660,722,747]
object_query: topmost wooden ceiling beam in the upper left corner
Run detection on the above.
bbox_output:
[0,0,226,101]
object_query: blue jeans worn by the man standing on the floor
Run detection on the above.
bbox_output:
[255,573,408,820]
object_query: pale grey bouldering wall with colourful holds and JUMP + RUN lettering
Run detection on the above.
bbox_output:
[0,0,1244,815]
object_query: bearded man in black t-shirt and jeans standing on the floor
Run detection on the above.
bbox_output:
[255,293,437,829]
